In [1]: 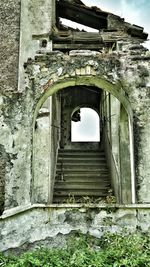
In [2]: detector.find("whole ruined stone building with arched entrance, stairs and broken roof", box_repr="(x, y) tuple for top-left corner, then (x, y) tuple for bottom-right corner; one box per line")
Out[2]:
(0, 0), (150, 251)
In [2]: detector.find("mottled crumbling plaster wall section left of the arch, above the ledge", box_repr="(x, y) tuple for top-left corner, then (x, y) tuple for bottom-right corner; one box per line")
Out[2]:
(0, 93), (32, 213)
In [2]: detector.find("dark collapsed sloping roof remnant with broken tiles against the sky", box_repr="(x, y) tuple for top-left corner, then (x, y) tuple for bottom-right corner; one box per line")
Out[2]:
(56, 0), (148, 40)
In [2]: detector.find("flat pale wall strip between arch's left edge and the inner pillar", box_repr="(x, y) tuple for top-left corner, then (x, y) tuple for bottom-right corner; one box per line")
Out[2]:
(32, 101), (50, 203)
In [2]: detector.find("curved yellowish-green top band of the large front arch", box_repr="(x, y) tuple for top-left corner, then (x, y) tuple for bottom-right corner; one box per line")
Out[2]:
(33, 75), (133, 121)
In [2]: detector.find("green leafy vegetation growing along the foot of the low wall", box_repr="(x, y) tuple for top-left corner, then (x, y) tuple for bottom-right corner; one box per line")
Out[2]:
(0, 233), (150, 267)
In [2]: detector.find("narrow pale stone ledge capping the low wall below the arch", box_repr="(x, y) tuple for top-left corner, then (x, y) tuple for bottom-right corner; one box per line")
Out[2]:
(0, 203), (150, 221)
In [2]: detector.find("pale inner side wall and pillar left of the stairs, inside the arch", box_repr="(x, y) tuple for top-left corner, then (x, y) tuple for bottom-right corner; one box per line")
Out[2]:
(32, 94), (61, 203)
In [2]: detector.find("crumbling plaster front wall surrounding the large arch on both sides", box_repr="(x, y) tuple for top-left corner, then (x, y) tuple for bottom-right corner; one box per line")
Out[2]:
(0, 44), (150, 216)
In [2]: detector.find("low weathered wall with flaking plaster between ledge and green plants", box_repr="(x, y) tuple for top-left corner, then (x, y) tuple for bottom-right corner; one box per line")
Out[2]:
(0, 204), (150, 253)
